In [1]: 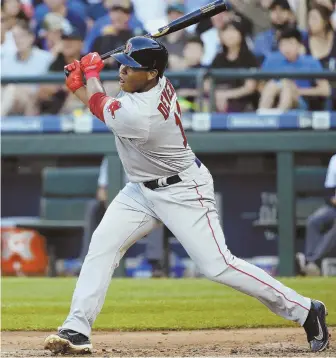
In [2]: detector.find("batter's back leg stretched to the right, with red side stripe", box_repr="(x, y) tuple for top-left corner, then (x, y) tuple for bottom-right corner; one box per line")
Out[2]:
(148, 162), (327, 348)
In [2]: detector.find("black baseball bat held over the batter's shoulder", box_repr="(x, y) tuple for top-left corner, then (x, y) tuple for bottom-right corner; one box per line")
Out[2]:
(64, 0), (231, 76)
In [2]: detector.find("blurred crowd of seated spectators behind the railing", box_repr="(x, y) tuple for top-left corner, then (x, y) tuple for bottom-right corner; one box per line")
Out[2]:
(1, 0), (336, 115)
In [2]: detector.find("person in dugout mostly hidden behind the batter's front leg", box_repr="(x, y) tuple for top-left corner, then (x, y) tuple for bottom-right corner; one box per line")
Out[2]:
(80, 158), (163, 277)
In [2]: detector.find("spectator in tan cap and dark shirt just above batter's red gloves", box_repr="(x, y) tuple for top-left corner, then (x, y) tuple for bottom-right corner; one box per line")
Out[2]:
(91, 1), (134, 69)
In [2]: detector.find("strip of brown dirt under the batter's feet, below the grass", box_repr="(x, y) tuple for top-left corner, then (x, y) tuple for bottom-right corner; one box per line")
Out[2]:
(1, 328), (336, 358)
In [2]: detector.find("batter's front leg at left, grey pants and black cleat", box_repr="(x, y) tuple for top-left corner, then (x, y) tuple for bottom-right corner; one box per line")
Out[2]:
(45, 184), (160, 353)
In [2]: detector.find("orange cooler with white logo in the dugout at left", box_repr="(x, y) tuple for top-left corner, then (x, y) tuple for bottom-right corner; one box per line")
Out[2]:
(1, 227), (48, 276)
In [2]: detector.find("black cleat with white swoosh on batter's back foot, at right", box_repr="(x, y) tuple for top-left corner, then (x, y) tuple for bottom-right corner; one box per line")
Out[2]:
(303, 300), (329, 352)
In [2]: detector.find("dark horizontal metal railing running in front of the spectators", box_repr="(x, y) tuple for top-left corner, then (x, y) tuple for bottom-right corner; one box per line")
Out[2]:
(1, 68), (336, 112)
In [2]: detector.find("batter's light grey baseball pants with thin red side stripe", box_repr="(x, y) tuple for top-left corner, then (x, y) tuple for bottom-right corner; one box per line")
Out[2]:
(62, 163), (311, 336)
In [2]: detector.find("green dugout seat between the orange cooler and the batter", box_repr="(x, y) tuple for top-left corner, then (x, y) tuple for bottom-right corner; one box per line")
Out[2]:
(16, 167), (99, 276)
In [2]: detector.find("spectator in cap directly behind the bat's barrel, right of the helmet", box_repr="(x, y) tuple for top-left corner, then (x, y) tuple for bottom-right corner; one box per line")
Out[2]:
(161, 3), (188, 70)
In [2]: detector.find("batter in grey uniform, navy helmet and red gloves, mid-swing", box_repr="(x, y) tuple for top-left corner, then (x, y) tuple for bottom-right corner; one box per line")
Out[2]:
(45, 36), (329, 354)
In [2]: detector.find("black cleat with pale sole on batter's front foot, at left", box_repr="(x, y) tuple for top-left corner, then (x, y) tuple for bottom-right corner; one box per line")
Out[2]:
(44, 329), (92, 354)
